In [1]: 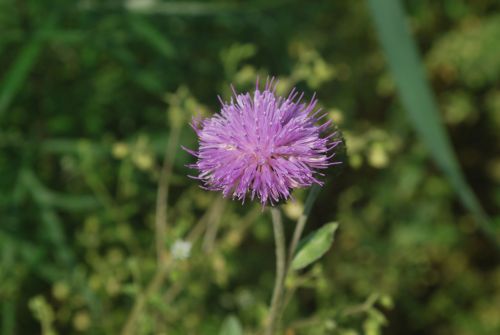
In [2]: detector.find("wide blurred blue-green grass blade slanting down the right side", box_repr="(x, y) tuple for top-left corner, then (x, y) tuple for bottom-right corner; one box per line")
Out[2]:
(368, 0), (498, 245)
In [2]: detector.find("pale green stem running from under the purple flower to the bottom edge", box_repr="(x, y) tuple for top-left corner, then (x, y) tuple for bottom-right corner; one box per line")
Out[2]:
(265, 207), (287, 335)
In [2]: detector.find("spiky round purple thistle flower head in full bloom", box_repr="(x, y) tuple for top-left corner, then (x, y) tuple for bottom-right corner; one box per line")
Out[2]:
(184, 80), (341, 205)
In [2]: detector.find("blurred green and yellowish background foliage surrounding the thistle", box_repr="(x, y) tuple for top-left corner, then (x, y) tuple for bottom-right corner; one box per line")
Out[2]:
(0, 0), (500, 335)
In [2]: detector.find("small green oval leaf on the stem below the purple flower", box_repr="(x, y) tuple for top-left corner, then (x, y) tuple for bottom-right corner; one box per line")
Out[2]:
(292, 222), (339, 270)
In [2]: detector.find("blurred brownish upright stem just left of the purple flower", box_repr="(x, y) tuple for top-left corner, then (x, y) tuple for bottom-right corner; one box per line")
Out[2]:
(155, 123), (181, 267)
